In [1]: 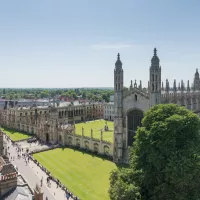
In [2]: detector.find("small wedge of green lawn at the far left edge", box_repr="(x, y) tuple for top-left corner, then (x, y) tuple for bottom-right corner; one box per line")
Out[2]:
(1, 128), (32, 141)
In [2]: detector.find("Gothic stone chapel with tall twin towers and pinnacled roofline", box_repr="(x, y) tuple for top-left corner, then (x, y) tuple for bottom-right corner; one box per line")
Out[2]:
(113, 48), (200, 163)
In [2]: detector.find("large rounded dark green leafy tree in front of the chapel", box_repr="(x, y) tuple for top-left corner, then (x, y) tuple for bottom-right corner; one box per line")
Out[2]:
(110, 104), (200, 200)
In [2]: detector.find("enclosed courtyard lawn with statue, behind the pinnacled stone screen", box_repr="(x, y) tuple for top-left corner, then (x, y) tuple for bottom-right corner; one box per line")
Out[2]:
(75, 120), (114, 142)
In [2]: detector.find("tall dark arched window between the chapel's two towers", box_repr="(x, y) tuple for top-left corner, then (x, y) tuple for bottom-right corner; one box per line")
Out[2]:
(127, 109), (144, 146)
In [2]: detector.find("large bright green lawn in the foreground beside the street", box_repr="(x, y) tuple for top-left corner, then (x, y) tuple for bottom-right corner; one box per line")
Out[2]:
(33, 148), (117, 200)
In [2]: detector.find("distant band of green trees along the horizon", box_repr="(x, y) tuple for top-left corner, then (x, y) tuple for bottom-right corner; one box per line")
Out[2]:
(0, 88), (114, 102)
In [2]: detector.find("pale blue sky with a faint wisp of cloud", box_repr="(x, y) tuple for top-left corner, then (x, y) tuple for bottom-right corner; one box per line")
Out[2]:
(0, 0), (200, 87)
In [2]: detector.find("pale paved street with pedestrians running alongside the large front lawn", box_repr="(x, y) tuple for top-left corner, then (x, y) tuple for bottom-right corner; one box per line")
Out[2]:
(7, 138), (74, 200)
